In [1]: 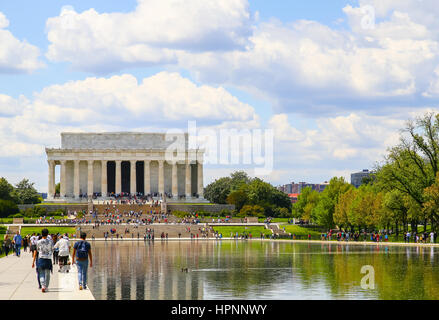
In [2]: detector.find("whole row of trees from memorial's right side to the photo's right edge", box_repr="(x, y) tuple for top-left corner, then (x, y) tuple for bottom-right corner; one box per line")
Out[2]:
(205, 113), (439, 234)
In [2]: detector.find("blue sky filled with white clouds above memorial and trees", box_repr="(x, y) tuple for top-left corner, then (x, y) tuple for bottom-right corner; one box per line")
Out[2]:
(0, 0), (439, 192)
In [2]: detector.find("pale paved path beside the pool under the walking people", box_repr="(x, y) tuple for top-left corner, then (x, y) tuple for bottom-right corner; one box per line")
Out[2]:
(0, 252), (94, 300)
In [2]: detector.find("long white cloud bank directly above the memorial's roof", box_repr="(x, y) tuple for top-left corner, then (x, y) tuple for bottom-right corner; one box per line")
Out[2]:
(0, 72), (258, 157)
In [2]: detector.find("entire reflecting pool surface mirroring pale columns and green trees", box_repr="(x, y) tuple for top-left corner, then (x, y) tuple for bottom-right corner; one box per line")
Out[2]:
(89, 241), (439, 300)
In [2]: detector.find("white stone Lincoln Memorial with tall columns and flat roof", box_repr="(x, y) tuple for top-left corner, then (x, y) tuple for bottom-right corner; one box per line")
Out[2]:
(46, 132), (204, 201)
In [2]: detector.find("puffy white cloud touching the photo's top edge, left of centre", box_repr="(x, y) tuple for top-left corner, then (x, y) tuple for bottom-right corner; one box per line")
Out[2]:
(46, 0), (250, 73)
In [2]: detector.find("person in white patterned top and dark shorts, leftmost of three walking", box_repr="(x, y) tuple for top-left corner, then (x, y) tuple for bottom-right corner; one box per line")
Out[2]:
(32, 229), (53, 292)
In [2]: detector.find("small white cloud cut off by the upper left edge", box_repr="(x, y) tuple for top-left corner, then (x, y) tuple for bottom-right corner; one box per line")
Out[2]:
(0, 12), (44, 74)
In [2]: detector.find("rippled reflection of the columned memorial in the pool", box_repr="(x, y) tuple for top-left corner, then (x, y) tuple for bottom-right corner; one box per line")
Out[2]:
(89, 240), (203, 300)
